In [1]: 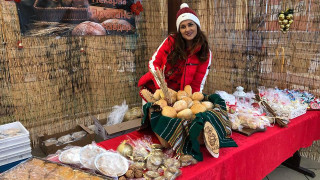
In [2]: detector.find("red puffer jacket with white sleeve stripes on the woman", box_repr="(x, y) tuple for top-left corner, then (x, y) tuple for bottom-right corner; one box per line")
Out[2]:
(138, 36), (212, 92)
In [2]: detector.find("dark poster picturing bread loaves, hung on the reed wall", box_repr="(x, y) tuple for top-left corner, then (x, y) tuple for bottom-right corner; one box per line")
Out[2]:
(16, 0), (139, 36)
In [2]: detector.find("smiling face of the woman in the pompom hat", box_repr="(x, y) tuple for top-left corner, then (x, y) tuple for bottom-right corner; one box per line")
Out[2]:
(179, 20), (197, 41)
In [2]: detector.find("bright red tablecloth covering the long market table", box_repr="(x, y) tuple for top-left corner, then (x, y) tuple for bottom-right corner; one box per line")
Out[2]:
(99, 111), (320, 180)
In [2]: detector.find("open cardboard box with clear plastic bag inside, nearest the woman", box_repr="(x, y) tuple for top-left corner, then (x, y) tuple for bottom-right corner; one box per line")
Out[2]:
(91, 116), (141, 142)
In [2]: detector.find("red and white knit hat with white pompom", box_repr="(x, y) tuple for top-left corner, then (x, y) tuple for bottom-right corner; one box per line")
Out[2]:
(176, 3), (200, 32)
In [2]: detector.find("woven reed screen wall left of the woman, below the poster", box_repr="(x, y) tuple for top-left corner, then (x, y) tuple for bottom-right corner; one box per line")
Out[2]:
(0, 0), (168, 145)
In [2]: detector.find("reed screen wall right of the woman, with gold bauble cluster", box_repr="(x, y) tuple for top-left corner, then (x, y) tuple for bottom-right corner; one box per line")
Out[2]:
(183, 0), (320, 161)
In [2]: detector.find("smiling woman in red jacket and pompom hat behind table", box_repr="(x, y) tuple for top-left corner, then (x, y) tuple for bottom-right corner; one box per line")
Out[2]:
(138, 3), (212, 98)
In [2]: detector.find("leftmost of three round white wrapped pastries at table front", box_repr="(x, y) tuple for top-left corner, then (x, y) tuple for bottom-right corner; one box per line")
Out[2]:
(59, 147), (81, 164)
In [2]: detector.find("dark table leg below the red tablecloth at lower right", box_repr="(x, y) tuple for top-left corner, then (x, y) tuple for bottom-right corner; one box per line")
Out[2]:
(282, 151), (316, 178)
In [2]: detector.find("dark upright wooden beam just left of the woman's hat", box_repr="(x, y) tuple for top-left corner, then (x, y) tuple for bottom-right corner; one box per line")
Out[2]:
(168, 0), (182, 34)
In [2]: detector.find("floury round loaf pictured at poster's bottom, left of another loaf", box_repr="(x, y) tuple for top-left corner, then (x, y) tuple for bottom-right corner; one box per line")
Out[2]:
(72, 21), (106, 36)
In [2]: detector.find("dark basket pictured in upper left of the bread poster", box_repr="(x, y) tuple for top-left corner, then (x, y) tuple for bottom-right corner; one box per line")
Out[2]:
(33, 0), (89, 23)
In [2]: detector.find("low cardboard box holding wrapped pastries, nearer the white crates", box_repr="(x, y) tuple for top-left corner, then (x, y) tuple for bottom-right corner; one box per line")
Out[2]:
(39, 124), (95, 155)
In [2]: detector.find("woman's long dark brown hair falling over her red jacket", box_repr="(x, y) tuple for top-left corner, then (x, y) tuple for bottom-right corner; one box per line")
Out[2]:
(167, 26), (209, 64)
